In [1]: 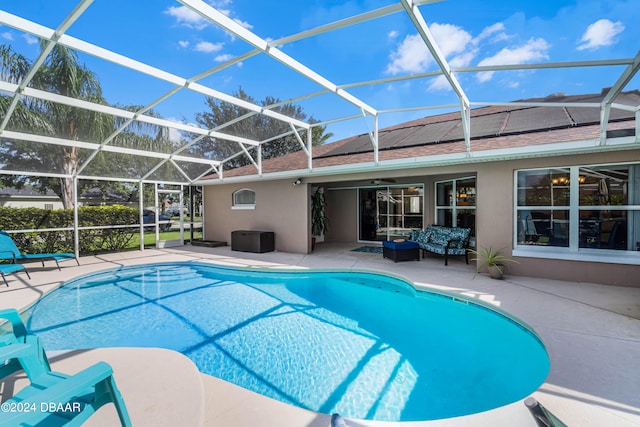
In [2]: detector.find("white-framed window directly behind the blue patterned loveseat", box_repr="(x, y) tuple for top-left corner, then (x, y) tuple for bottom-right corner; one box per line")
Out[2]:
(436, 177), (476, 241)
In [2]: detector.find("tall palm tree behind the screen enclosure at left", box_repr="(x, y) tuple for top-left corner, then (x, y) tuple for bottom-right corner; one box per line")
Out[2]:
(0, 44), (171, 208)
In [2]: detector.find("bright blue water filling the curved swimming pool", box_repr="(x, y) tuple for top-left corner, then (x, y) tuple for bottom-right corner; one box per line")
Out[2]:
(28, 263), (549, 421)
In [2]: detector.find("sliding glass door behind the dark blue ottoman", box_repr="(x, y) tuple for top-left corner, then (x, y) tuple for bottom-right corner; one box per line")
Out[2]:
(358, 185), (424, 241)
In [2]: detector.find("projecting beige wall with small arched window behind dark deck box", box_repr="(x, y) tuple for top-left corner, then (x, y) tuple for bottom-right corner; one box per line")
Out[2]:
(204, 180), (310, 253)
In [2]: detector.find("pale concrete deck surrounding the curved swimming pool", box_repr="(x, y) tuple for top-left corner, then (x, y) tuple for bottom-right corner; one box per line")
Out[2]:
(0, 244), (640, 427)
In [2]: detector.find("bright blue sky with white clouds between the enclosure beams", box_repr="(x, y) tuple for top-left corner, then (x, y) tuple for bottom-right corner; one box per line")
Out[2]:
(0, 0), (640, 139)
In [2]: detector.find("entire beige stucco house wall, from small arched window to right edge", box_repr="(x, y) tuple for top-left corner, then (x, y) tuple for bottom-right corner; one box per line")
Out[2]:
(204, 149), (640, 286)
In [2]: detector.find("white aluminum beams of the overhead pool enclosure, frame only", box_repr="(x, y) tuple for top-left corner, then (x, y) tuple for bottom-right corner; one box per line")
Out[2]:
(0, 0), (640, 189)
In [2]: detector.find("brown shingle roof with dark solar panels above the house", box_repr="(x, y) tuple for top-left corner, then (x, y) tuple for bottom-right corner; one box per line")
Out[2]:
(210, 90), (640, 178)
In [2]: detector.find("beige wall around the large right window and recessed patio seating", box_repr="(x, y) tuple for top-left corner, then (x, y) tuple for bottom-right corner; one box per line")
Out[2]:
(320, 150), (640, 286)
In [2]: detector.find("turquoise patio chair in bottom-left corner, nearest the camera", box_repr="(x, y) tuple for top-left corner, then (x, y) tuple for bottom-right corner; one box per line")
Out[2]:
(0, 342), (131, 427)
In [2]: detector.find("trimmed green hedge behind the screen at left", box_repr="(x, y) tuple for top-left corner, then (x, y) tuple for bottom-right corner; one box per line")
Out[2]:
(0, 205), (140, 254)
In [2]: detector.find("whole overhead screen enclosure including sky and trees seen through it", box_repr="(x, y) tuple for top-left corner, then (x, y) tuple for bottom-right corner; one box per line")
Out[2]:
(0, 0), (640, 251)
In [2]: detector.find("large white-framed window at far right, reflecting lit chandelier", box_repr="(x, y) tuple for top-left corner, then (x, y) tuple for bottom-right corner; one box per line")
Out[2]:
(515, 164), (640, 253)
